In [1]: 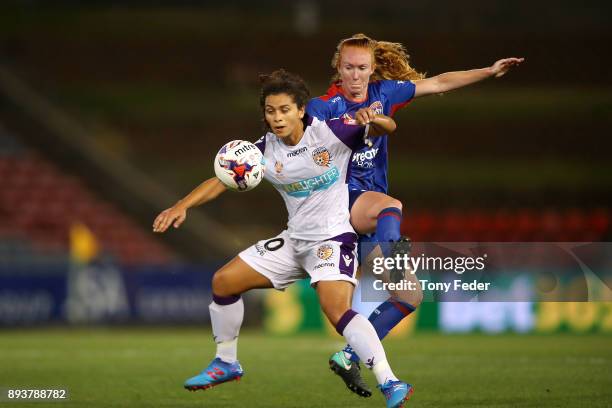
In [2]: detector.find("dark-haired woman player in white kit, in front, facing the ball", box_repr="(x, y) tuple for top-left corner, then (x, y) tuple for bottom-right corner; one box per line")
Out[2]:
(153, 70), (412, 407)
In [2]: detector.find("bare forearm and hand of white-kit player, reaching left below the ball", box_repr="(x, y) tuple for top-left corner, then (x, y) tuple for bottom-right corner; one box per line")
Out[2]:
(153, 177), (227, 232)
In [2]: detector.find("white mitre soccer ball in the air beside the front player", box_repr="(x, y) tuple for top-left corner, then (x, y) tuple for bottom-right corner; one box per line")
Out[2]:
(215, 140), (265, 191)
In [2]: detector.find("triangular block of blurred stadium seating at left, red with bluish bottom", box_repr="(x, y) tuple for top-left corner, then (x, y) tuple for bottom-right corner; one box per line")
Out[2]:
(0, 128), (175, 266)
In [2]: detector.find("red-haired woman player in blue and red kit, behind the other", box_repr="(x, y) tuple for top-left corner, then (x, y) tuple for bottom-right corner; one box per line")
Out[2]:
(306, 34), (523, 397)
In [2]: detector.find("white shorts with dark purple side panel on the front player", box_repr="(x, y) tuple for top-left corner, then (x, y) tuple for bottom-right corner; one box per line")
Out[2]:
(238, 230), (357, 290)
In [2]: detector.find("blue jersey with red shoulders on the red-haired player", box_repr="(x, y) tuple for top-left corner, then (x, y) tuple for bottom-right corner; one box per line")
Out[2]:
(306, 80), (415, 194)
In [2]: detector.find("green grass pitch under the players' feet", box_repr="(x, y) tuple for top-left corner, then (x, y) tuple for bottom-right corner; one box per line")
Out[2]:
(0, 328), (612, 408)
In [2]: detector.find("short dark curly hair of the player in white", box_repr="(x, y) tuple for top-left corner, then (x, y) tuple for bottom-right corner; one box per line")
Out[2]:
(259, 68), (310, 130)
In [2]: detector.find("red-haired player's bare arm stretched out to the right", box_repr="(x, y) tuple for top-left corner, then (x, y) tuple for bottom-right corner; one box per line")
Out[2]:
(414, 58), (525, 98)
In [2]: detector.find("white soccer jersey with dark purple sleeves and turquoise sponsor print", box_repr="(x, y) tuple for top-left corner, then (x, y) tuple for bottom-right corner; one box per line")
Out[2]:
(255, 117), (365, 241)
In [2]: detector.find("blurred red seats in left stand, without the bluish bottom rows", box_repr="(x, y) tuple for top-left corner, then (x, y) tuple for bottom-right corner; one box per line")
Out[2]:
(0, 151), (177, 263)
